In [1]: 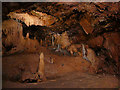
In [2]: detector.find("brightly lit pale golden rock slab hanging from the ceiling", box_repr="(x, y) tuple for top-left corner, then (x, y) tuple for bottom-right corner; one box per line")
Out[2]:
(7, 10), (55, 26)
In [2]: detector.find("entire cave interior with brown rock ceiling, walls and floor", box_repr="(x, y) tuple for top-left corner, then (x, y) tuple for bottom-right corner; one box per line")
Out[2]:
(1, 2), (120, 88)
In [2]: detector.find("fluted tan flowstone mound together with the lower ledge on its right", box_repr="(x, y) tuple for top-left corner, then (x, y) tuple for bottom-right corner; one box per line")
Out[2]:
(2, 19), (39, 55)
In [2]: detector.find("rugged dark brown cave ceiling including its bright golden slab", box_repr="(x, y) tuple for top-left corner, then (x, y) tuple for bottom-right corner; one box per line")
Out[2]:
(3, 2), (120, 35)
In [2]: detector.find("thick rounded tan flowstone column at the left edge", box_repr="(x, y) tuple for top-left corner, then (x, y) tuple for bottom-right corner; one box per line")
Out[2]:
(2, 19), (24, 54)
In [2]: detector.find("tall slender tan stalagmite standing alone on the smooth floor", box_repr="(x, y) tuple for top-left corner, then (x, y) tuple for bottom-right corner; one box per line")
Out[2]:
(38, 53), (46, 81)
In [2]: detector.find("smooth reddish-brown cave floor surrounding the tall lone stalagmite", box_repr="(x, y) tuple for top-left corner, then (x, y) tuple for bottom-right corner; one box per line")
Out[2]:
(2, 47), (119, 88)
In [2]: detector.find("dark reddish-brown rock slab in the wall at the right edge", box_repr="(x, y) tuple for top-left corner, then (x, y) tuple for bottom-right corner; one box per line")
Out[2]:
(104, 33), (120, 63)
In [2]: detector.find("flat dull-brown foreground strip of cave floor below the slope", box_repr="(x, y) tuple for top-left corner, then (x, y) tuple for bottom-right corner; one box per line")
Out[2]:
(3, 72), (118, 88)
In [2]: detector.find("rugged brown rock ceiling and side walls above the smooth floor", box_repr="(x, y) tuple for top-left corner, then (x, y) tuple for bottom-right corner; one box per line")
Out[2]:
(2, 2), (120, 74)
